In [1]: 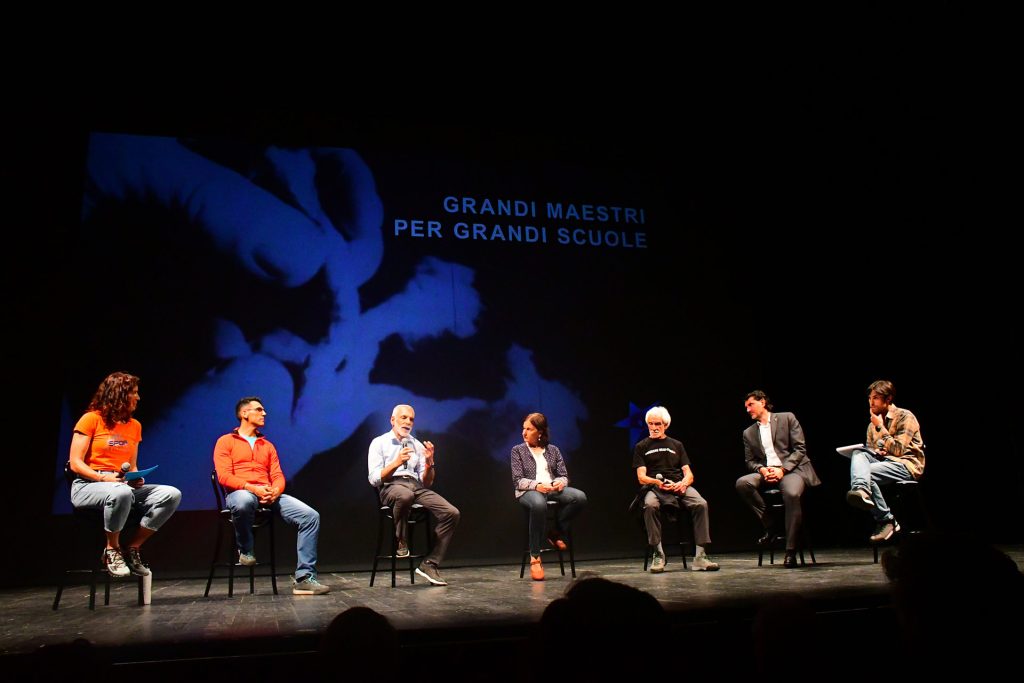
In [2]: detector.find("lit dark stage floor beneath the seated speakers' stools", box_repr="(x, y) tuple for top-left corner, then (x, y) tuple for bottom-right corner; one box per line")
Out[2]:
(0, 547), (1024, 675)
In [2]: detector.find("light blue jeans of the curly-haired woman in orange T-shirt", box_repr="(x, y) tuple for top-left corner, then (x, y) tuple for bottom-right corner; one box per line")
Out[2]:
(71, 479), (181, 532)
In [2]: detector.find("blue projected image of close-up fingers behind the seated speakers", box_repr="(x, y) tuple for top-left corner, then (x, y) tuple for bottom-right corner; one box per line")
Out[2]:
(54, 134), (588, 512)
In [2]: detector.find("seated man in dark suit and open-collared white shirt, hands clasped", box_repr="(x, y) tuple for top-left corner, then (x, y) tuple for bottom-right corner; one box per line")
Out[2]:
(736, 389), (821, 568)
